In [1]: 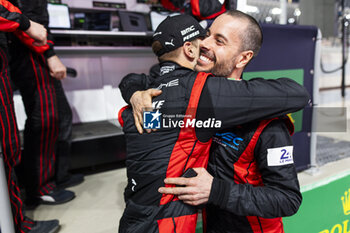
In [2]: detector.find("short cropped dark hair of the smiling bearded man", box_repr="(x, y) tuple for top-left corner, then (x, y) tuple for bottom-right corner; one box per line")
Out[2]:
(224, 10), (263, 57)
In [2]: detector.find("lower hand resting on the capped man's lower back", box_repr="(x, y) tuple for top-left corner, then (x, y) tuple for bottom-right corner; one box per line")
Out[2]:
(158, 168), (213, 206)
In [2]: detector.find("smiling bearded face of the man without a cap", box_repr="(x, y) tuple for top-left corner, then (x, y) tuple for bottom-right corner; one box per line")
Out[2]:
(196, 14), (248, 77)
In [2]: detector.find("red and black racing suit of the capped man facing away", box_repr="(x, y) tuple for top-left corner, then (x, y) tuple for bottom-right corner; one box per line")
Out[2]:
(118, 62), (309, 233)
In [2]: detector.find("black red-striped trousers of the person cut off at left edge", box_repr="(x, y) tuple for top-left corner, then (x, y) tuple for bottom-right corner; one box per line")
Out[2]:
(0, 45), (34, 233)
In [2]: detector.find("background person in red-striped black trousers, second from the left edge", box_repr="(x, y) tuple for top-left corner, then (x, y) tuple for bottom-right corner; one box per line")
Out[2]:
(9, 0), (83, 207)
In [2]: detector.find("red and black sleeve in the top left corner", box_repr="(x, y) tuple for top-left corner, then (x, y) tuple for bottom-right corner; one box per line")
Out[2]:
(0, 0), (30, 32)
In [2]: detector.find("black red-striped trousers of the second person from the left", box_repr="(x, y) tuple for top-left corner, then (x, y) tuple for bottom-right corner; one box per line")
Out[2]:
(9, 36), (72, 197)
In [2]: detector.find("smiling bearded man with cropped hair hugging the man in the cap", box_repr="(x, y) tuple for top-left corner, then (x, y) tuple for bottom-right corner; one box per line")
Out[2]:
(152, 11), (302, 233)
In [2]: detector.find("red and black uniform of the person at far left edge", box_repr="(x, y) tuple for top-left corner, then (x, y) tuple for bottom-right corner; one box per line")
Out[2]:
(0, 0), (34, 233)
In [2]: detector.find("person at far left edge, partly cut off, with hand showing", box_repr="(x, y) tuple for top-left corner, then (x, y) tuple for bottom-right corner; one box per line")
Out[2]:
(0, 0), (59, 233)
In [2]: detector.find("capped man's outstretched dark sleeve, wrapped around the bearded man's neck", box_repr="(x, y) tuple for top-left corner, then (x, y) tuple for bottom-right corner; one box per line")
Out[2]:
(197, 77), (310, 141)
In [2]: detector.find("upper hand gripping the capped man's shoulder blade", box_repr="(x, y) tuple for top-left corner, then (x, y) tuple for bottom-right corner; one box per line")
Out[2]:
(130, 89), (162, 134)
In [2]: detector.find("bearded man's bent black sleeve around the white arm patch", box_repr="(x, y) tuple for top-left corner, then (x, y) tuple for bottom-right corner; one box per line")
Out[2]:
(208, 121), (302, 218)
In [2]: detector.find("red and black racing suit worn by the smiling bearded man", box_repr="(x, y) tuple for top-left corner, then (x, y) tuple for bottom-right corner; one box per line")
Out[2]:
(206, 117), (302, 233)
